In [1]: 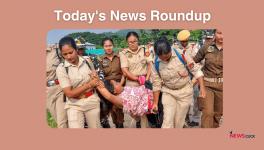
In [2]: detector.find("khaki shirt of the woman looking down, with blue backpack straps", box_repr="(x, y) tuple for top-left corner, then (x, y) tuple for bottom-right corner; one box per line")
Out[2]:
(151, 50), (203, 92)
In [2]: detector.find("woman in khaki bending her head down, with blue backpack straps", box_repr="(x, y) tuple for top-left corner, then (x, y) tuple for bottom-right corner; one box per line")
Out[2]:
(151, 38), (205, 128)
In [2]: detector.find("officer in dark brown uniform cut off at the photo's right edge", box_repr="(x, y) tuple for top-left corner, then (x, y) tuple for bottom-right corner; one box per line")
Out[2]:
(194, 29), (223, 128)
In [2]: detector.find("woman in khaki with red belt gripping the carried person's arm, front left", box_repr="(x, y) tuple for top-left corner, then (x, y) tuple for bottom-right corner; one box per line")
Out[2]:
(56, 37), (100, 128)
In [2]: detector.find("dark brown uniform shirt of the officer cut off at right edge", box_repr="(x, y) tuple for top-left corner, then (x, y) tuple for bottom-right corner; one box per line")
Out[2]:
(194, 43), (223, 78)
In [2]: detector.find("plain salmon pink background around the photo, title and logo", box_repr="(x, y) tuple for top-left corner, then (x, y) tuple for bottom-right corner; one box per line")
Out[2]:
(0, 0), (264, 150)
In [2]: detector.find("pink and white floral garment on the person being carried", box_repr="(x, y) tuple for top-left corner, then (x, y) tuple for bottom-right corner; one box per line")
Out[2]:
(120, 85), (153, 116)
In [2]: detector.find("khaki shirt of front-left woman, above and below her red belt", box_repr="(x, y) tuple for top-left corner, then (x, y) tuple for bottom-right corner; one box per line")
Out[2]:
(56, 56), (100, 111)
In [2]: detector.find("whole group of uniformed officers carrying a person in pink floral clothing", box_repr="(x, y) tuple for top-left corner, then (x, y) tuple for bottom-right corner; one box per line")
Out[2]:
(46, 29), (223, 128)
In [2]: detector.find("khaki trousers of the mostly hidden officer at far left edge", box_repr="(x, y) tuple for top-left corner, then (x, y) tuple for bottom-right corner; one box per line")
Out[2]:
(46, 85), (68, 128)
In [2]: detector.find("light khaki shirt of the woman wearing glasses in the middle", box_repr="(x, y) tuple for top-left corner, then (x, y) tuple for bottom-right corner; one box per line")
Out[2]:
(119, 47), (153, 86)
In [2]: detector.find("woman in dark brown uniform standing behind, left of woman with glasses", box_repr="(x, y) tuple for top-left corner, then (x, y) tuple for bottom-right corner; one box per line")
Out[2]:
(100, 38), (125, 128)
